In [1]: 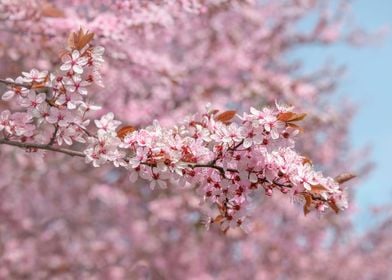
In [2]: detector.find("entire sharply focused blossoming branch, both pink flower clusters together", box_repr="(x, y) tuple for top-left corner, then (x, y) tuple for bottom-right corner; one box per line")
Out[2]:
(0, 30), (346, 231)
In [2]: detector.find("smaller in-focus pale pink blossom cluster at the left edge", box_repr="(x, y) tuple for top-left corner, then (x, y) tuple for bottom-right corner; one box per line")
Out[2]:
(0, 30), (104, 145)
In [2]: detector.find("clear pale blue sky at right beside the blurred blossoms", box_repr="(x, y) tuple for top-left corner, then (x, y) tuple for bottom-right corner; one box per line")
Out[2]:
(297, 0), (392, 230)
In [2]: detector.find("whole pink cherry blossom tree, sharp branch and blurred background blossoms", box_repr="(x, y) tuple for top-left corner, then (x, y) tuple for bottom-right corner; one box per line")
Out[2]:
(0, 0), (392, 279)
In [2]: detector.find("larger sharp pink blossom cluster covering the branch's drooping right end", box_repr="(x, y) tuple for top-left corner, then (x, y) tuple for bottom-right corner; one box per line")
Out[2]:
(90, 105), (346, 230)
